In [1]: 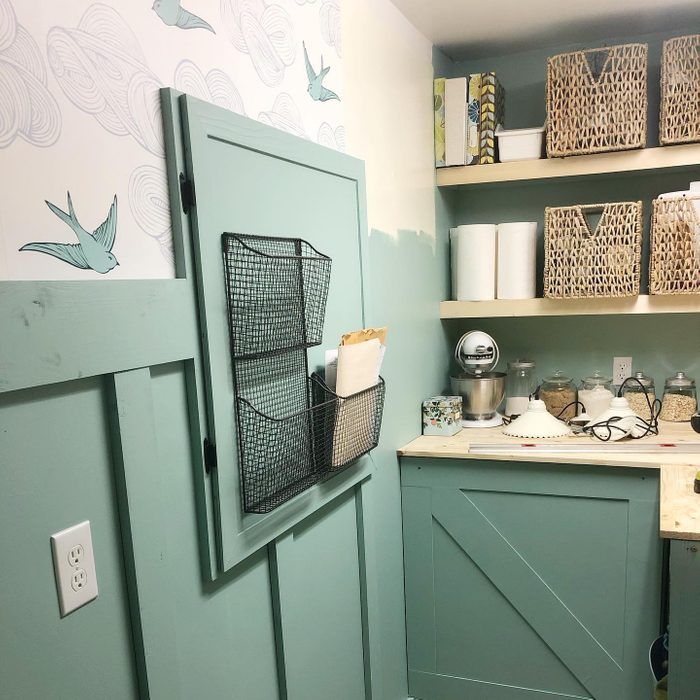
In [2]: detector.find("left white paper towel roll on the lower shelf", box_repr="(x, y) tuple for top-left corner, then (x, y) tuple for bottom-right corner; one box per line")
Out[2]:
(452, 224), (496, 301)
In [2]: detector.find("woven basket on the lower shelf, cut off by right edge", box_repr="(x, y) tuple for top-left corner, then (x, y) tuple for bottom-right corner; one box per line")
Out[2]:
(649, 197), (700, 294)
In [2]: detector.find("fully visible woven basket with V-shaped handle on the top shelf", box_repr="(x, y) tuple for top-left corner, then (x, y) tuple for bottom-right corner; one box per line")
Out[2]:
(547, 44), (648, 158)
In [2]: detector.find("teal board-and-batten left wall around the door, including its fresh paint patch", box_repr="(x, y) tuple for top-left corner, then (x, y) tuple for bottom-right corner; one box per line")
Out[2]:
(0, 86), (447, 700)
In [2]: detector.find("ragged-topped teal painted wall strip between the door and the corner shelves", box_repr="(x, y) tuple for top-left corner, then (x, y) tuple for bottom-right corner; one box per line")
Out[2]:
(366, 229), (447, 700)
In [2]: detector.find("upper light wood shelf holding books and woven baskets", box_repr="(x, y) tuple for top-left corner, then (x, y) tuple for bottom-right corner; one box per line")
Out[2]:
(437, 144), (700, 187)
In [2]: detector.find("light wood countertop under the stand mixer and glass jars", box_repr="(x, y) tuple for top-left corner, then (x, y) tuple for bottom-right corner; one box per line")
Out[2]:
(397, 422), (700, 540)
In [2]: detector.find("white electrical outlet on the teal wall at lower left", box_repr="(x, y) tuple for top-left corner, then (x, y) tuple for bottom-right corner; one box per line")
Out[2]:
(51, 520), (97, 617)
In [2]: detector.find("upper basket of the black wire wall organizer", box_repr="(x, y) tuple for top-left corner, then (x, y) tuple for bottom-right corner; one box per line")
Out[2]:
(222, 233), (331, 359)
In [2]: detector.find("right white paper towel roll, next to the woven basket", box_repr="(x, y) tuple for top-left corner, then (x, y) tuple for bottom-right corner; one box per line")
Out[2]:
(497, 221), (537, 299)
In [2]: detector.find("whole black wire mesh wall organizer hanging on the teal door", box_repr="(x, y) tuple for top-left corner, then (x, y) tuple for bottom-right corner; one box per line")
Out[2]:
(222, 233), (385, 513)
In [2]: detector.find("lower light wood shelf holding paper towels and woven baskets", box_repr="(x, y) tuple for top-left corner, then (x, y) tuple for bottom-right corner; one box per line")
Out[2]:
(440, 292), (700, 319)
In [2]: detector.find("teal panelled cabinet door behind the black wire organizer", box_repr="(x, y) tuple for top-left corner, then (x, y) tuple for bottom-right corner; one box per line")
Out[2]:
(172, 91), (372, 570)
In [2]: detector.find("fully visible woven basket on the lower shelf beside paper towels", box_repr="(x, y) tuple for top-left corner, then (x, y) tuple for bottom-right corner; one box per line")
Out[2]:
(544, 202), (642, 299)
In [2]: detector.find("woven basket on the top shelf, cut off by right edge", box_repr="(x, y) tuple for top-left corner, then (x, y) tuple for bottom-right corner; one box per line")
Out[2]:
(659, 34), (700, 145)
